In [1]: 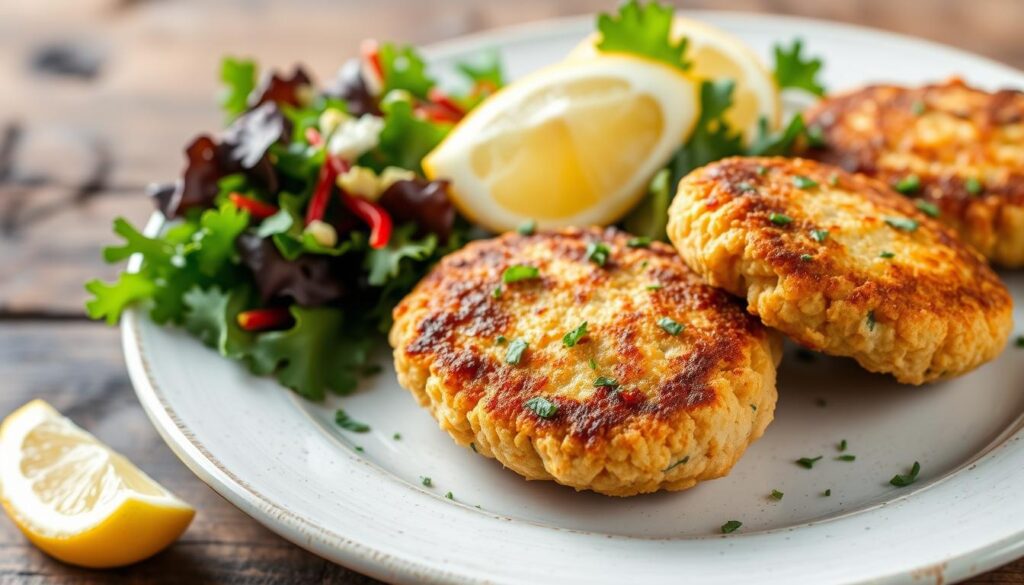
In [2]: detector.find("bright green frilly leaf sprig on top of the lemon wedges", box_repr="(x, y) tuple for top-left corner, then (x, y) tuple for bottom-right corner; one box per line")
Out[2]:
(597, 0), (690, 71)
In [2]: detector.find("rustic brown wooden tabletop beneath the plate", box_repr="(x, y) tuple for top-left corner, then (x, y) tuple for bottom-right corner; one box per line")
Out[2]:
(0, 0), (1024, 584)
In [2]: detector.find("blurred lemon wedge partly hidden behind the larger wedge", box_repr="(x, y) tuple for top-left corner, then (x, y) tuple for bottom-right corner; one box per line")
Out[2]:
(568, 16), (781, 141)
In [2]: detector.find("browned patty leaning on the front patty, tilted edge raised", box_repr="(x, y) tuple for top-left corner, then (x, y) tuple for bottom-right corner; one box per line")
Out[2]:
(669, 158), (1012, 384)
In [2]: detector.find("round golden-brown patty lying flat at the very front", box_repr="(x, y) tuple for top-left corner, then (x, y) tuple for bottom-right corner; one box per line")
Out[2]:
(390, 228), (780, 496)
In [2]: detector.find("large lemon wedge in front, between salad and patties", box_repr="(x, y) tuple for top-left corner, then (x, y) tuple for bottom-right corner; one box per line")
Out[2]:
(423, 54), (698, 232)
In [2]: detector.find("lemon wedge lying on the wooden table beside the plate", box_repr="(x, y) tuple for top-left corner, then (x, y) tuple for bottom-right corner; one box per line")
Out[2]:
(0, 401), (195, 568)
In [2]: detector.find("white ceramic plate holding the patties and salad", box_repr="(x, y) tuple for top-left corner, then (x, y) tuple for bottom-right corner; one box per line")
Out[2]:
(124, 12), (1024, 584)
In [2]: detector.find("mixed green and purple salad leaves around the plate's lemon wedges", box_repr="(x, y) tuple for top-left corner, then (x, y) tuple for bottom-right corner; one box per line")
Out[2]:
(86, 0), (823, 400)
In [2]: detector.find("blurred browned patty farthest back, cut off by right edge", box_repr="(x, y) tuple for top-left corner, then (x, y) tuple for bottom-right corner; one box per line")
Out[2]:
(805, 80), (1024, 266)
